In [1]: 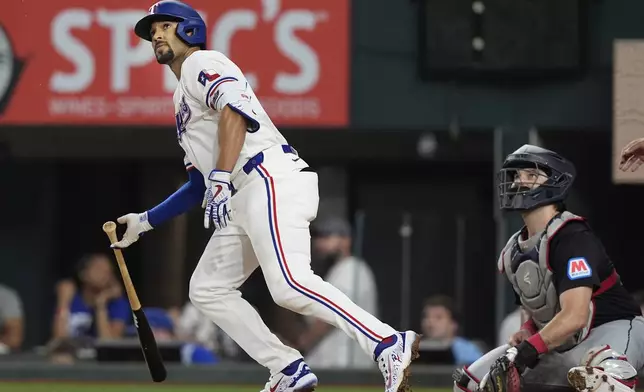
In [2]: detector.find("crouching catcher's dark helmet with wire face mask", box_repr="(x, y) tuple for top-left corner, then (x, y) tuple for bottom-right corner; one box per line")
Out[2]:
(497, 144), (577, 211)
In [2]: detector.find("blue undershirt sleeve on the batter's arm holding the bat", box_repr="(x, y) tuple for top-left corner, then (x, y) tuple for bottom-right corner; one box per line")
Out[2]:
(148, 168), (206, 227)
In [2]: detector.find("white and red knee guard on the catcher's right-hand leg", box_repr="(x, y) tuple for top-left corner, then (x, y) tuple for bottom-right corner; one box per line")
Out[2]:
(568, 344), (638, 392)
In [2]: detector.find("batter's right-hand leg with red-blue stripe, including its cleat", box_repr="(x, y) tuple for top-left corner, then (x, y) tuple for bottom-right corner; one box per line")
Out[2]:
(240, 165), (419, 390)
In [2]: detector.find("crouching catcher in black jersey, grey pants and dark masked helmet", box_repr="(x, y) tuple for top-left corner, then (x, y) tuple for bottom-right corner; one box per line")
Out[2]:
(454, 145), (644, 392)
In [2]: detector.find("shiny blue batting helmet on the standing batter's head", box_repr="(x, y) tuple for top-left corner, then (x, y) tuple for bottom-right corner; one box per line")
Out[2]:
(134, 0), (206, 49)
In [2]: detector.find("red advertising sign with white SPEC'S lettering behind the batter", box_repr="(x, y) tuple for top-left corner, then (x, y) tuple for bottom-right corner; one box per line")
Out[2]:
(0, 0), (350, 127)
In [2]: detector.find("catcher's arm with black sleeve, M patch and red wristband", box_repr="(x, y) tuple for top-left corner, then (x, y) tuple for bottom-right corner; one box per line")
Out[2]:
(528, 231), (603, 353)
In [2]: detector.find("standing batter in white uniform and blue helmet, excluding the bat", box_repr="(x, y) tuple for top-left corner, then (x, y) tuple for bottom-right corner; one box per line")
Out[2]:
(115, 0), (420, 392)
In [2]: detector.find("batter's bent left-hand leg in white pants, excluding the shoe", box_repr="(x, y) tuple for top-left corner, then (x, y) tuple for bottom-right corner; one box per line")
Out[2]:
(189, 225), (302, 374)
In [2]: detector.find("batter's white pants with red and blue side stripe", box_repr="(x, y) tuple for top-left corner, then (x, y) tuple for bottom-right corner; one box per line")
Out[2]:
(189, 145), (396, 374)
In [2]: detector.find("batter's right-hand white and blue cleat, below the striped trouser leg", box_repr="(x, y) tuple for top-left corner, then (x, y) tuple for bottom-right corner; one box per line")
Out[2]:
(374, 331), (421, 392)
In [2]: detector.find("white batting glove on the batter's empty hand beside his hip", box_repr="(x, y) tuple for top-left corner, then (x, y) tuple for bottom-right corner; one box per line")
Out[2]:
(201, 169), (233, 230)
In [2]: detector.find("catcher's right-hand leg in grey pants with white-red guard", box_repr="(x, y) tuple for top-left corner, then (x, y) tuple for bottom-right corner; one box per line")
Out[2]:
(564, 317), (644, 392)
